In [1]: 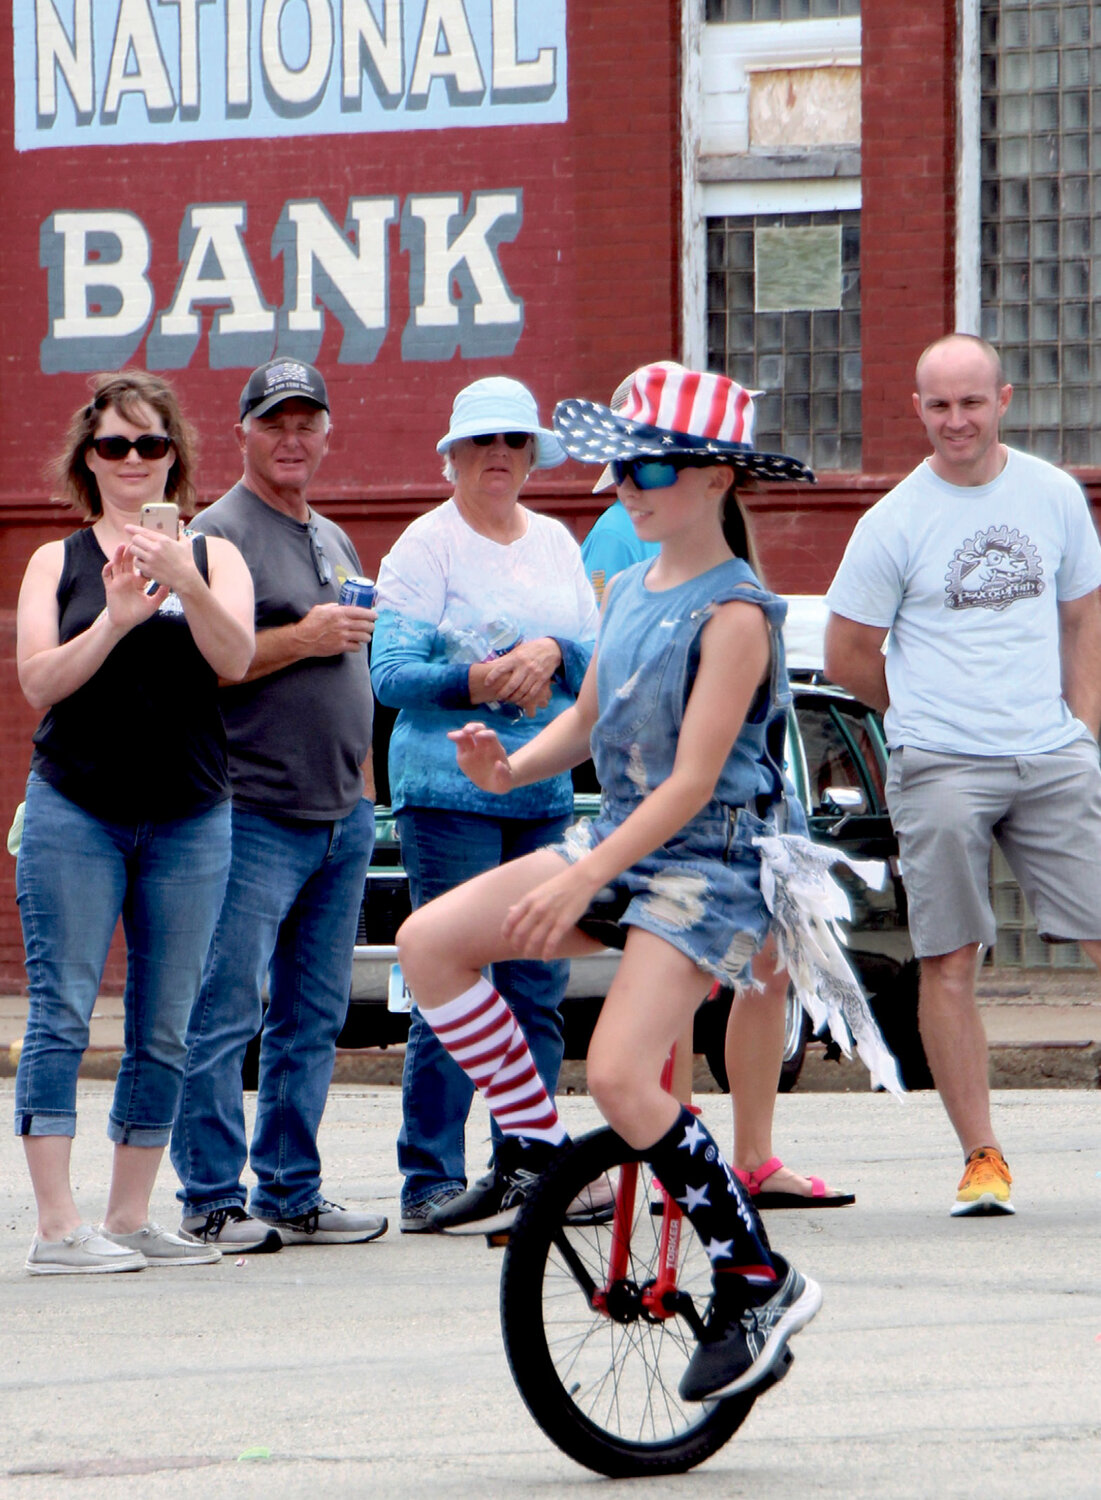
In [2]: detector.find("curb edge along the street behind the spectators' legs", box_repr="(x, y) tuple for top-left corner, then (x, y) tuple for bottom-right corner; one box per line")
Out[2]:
(0, 1041), (1101, 1094)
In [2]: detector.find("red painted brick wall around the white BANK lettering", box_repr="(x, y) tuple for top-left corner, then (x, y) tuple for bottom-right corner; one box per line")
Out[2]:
(0, 0), (690, 987)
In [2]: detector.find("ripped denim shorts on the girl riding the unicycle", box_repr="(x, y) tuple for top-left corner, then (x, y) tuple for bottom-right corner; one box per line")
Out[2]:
(549, 807), (776, 984)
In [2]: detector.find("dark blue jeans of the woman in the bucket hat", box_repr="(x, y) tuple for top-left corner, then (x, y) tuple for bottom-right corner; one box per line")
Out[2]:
(398, 807), (570, 1211)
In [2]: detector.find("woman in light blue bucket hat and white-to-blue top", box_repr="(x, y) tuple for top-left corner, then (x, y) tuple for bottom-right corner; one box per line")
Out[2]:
(371, 375), (597, 1235)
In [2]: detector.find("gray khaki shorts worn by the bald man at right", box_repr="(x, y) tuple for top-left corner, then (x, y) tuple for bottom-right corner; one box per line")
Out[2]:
(887, 734), (1101, 959)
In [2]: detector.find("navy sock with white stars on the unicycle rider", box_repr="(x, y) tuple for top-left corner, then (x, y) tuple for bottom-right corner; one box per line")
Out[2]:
(644, 1109), (776, 1281)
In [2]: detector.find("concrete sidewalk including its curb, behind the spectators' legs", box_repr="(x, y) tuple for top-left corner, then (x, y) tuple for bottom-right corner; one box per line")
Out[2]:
(0, 969), (1101, 1094)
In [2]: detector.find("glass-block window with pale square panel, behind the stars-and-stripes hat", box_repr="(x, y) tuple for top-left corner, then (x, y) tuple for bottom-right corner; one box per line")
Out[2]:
(708, 209), (861, 471)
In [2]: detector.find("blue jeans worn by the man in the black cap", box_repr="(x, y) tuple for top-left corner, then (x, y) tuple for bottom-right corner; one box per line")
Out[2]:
(173, 801), (375, 1218)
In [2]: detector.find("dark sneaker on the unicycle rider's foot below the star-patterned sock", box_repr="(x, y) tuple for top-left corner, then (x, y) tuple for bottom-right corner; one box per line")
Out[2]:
(680, 1254), (822, 1401)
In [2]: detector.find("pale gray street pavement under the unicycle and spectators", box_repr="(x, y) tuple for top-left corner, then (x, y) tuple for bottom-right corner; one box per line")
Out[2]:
(0, 1079), (1101, 1500)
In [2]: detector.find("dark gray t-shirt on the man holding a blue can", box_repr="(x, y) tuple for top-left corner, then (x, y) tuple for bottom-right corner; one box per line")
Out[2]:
(194, 483), (374, 822)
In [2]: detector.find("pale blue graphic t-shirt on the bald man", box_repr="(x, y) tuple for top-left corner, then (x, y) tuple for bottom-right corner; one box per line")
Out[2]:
(827, 449), (1101, 756)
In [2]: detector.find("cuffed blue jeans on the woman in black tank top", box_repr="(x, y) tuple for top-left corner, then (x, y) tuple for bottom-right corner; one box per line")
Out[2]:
(15, 773), (230, 1146)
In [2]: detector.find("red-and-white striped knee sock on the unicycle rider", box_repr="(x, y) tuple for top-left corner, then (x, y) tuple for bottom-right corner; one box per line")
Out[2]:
(422, 980), (569, 1146)
